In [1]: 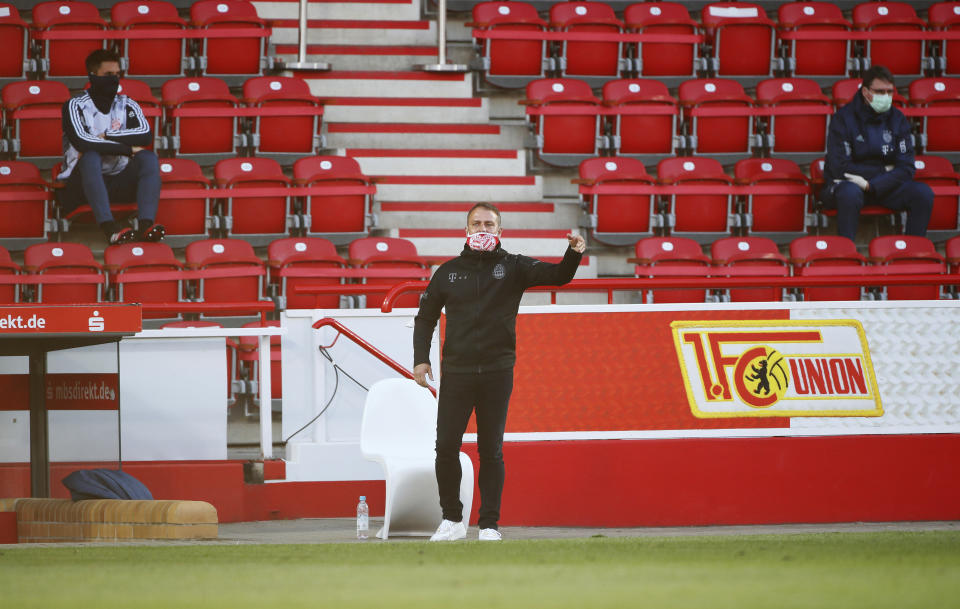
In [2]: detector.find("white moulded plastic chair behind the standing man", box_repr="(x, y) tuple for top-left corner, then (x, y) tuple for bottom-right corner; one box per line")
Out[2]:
(360, 378), (473, 540)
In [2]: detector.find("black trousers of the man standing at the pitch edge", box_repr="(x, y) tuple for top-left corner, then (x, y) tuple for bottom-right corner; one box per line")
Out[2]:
(436, 368), (513, 529)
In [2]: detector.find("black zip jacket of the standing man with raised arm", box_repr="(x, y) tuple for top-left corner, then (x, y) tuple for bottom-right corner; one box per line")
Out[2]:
(413, 245), (581, 373)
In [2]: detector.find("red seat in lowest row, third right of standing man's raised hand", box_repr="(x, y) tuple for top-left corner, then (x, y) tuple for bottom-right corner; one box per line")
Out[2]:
(790, 235), (873, 301)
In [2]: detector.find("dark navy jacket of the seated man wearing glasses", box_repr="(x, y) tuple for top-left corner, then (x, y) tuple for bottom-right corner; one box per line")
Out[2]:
(823, 91), (914, 197)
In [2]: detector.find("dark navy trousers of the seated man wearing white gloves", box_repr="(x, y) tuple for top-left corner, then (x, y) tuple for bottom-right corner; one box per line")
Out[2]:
(820, 180), (933, 241)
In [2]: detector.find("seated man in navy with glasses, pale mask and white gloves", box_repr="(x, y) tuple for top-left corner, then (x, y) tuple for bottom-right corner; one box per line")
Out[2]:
(820, 66), (933, 241)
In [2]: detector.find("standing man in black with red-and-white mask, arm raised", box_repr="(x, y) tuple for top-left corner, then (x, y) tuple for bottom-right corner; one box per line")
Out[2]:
(413, 203), (585, 541)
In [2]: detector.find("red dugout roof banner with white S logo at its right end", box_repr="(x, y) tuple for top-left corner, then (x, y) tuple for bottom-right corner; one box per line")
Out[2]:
(0, 304), (142, 337)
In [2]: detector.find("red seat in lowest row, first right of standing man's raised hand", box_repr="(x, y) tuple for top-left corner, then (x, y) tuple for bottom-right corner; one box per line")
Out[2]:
(630, 237), (712, 304)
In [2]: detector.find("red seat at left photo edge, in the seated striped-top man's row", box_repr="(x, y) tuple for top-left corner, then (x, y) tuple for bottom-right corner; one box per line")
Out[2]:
(0, 161), (52, 246)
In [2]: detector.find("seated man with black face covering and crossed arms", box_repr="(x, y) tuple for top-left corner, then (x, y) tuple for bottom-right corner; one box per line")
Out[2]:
(57, 49), (165, 245)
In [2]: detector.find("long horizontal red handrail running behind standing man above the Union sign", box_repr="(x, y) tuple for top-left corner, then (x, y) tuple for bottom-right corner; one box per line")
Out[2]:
(380, 276), (960, 313)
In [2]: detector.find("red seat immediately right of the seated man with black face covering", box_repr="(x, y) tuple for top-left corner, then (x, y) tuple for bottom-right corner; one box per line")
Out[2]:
(156, 159), (212, 242)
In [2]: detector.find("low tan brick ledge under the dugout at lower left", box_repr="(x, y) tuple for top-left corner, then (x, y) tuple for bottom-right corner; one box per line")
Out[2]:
(12, 499), (218, 543)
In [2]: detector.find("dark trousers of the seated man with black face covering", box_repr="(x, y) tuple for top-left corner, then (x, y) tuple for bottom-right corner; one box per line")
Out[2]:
(61, 150), (160, 224)
